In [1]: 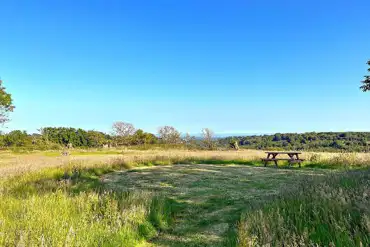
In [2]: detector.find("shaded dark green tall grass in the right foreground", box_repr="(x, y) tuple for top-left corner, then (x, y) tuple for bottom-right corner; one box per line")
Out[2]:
(238, 169), (370, 247)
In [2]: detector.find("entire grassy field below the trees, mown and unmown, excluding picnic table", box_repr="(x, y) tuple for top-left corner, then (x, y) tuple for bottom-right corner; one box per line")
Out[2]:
(0, 150), (370, 246)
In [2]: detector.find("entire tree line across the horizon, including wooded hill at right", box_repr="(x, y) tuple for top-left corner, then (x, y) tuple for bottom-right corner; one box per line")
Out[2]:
(0, 125), (370, 152)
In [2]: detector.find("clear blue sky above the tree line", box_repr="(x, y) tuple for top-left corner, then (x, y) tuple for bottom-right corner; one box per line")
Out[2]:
(0, 0), (370, 133)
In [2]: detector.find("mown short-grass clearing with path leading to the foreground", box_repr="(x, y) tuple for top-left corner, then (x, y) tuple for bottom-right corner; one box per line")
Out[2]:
(103, 165), (323, 246)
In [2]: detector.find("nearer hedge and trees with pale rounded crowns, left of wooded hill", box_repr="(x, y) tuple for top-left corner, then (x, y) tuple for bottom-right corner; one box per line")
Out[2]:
(0, 121), (217, 150)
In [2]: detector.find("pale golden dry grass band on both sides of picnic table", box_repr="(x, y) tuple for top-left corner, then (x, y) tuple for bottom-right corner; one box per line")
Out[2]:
(0, 149), (370, 178)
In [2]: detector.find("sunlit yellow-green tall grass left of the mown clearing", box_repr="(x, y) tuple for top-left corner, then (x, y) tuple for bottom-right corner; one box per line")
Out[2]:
(0, 157), (178, 246)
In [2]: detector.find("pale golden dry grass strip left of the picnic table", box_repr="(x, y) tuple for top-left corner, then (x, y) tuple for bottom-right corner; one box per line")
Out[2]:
(0, 150), (264, 178)
